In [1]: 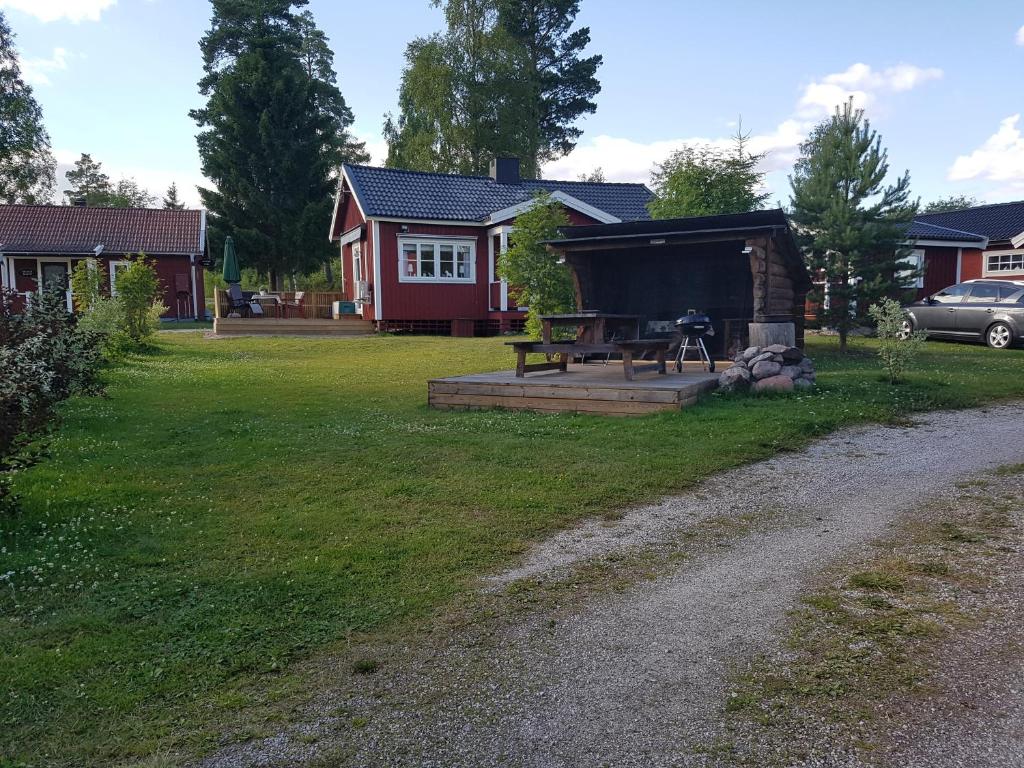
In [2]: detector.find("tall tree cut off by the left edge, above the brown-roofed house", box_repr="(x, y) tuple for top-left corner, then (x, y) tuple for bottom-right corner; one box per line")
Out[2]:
(0, 12), (56, 204)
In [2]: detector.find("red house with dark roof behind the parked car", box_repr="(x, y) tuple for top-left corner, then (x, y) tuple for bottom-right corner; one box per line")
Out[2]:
(908, 201), (1024, 297)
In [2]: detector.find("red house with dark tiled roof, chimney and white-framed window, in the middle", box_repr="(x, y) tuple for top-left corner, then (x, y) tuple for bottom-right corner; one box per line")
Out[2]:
(331, 158), (652, 335)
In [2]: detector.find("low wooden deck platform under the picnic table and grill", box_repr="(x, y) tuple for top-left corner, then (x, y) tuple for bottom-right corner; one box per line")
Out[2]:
(427, 361), (718, 416)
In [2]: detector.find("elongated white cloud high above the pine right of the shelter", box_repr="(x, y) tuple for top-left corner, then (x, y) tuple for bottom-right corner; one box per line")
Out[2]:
(798, 62), (942, 117)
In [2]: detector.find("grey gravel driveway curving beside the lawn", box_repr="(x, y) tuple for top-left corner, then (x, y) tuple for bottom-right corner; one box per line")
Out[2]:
(205, 406), (1024, 768)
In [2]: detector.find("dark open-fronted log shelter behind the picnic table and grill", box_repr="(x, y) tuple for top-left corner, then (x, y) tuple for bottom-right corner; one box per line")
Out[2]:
(547, 209), (811, 354)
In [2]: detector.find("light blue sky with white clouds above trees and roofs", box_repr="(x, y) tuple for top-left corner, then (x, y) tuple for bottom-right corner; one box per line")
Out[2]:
(8, 0), (1024, 210)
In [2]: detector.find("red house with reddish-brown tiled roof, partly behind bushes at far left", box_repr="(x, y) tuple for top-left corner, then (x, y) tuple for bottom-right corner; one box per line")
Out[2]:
(0, 205), (207, 319)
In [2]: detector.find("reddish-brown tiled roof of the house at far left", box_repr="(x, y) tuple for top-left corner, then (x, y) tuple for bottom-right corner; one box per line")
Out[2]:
(0, 205), (206, 255)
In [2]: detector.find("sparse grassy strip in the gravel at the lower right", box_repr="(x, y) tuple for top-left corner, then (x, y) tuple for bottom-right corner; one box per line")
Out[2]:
(725, 471), (1024, 765)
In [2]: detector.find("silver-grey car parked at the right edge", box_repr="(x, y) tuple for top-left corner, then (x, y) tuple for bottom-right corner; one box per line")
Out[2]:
(903, 280), (1024, 349)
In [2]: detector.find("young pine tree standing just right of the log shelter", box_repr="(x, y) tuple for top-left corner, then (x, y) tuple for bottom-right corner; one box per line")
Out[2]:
(790, 100), (918, 352)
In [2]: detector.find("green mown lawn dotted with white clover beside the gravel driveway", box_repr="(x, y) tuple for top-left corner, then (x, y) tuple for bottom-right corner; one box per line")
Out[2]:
(0, 333), (1024, 766)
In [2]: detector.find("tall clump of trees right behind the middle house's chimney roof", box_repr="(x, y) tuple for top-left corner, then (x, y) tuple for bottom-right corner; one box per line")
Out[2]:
(384, 0), (601, 178)
